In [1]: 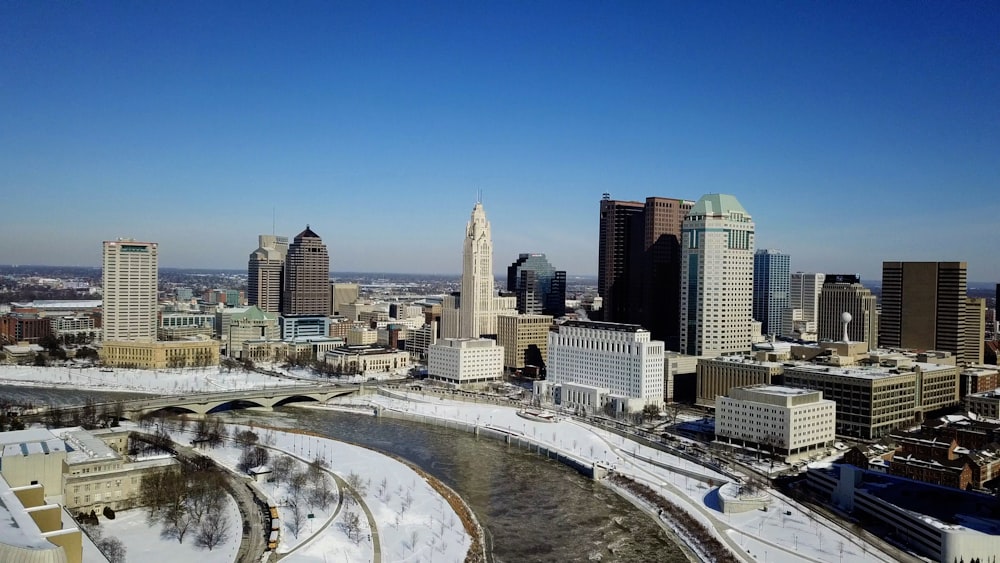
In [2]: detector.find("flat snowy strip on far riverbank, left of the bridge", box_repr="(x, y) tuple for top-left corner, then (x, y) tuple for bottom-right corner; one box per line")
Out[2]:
(0, 365), (312, 395)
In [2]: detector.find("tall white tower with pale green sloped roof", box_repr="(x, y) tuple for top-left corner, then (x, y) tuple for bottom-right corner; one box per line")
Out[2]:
(680, 194), (754, 356)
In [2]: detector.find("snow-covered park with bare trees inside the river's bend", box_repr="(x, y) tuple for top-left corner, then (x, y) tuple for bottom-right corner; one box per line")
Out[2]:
(129, 425), (472, 563)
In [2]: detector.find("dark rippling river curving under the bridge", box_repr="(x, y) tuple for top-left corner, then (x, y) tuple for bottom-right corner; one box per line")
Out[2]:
(0, 386), (687, 563)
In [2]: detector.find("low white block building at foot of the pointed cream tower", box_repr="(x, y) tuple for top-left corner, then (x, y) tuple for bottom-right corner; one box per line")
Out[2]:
(427, 338), (503, 385)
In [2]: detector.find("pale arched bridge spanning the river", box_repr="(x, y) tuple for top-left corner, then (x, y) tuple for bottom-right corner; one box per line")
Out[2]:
(123, 385), (364, 420)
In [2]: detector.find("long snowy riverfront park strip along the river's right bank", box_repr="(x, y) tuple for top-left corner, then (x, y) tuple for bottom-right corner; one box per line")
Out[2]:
(344, 392), (893, 562)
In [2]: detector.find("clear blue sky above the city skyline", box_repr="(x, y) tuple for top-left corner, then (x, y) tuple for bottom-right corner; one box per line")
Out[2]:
(0, 1), (1000, 281)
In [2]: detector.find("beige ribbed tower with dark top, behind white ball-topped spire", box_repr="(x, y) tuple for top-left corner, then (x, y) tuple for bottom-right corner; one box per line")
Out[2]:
(816, 274), (879, 350)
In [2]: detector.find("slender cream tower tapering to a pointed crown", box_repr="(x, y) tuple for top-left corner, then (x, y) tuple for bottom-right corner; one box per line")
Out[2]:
(458, 201), (497, 338)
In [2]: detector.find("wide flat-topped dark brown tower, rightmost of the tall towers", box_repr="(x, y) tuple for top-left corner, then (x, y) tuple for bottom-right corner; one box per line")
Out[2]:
(879, 262), (966, 362)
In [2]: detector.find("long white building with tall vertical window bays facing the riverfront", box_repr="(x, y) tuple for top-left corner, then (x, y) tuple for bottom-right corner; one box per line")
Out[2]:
(547, 321), (664, 410)
